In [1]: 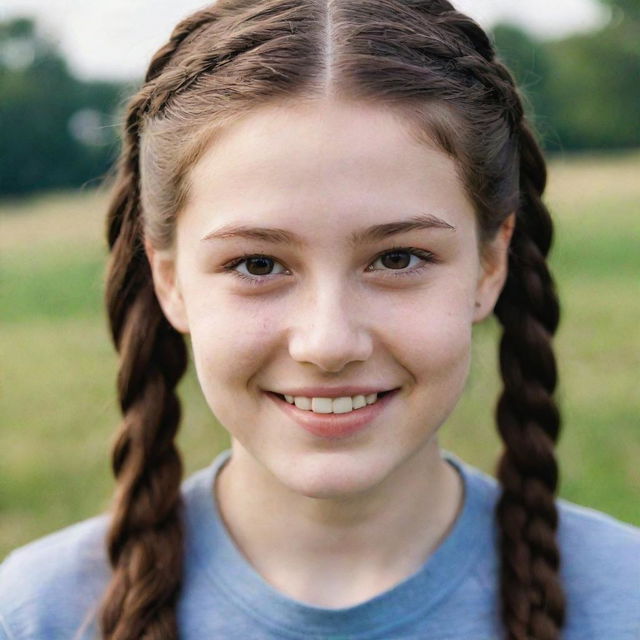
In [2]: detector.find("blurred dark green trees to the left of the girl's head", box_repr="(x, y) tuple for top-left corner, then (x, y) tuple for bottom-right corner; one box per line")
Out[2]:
(0, 18), (123, 196)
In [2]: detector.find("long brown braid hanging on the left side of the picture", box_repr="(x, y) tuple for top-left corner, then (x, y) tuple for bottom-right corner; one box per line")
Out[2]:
(100, 17), (204, 640)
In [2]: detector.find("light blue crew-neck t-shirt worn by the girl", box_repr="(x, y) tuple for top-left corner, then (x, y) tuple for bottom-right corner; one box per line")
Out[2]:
(0, 449), (640, 640)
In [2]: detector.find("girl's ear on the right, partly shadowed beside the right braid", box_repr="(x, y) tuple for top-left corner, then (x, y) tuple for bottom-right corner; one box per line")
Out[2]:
(473, 213), (516, 324)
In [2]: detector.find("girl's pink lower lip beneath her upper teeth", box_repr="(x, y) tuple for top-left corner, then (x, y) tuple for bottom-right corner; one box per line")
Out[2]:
(265, 389), (399, 440)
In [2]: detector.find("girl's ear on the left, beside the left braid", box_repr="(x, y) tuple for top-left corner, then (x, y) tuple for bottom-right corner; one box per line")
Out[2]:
(144, 240), (189, 333)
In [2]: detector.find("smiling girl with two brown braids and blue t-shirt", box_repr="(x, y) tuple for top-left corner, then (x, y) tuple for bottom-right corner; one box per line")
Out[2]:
(0, 0), (640, 640)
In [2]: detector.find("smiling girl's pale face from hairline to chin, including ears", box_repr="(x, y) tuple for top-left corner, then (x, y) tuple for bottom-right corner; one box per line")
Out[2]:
(147, 102), (510, 497)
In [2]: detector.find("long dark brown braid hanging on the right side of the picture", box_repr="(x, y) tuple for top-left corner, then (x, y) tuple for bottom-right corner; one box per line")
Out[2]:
(495, 117), (565, 640)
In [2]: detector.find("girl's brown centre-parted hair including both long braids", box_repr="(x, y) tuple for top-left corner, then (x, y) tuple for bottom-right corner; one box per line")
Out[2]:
(100, 0), (565, 640)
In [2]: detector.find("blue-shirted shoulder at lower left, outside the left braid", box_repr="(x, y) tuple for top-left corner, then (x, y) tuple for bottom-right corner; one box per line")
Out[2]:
(0, 514), (108, 640)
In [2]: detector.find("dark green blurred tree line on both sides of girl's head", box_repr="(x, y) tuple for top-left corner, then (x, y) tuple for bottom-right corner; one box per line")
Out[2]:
(0, 0), (640, 197)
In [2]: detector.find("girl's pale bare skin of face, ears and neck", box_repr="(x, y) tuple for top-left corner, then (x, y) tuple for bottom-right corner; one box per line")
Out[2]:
(146, 99), (515, 608)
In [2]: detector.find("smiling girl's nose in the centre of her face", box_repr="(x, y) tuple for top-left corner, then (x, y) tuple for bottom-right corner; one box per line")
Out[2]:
(289, 283), (373, 373)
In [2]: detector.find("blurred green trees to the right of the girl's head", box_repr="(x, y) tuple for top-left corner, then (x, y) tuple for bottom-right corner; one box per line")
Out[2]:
(493, 0), (640, 152)
